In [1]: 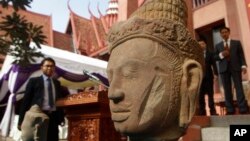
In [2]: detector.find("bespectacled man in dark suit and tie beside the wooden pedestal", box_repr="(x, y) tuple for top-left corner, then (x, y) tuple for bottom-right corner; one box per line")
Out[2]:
(18, 58), (64, 141)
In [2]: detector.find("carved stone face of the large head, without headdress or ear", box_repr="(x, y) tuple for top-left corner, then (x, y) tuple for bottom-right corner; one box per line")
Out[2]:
(107, 38), (180, 134)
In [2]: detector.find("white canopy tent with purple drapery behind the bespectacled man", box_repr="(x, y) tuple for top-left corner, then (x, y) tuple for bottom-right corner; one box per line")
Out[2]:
(0, 44), (107, 136)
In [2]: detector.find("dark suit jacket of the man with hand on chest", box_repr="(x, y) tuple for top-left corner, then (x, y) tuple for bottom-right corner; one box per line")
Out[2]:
(215, 40), (247, 73)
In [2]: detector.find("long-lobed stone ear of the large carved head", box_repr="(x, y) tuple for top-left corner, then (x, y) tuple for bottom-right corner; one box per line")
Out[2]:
(179, 60), (202, 127)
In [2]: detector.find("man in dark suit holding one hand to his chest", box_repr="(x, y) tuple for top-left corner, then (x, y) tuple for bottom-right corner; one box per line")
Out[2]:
(215, 27), (248, 115)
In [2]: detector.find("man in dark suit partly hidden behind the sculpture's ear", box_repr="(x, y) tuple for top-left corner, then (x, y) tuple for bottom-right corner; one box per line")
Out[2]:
(198, 39), (218, 116)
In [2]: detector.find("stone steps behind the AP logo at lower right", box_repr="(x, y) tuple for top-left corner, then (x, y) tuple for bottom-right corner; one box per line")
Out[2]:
(182, 115), (250, 141)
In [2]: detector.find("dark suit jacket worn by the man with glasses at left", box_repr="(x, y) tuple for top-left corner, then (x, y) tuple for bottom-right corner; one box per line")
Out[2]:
(18, 76), (64, 125)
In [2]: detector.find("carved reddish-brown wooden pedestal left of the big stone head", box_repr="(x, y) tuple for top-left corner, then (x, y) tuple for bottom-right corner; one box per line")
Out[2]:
(57, 91), (125, 141)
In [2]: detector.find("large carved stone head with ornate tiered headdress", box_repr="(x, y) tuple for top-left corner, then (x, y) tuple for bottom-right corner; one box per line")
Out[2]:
(107, 0), (203, 141)
